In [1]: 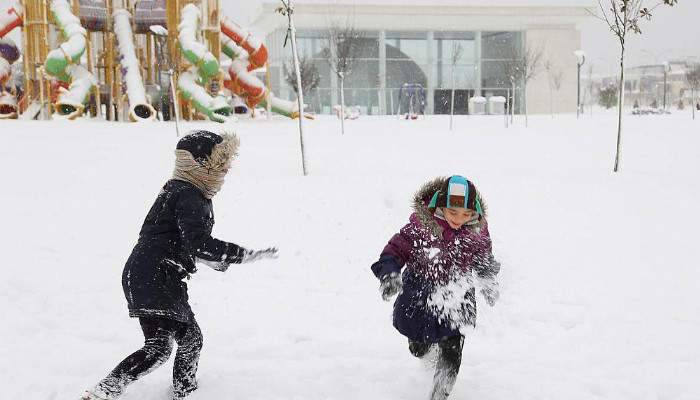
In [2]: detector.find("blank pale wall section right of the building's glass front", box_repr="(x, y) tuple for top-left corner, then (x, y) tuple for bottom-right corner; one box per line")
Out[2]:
(525, 26), (585, 114)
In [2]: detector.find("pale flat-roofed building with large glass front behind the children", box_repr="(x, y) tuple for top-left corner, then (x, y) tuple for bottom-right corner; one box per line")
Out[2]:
(253, 0), (590, 114)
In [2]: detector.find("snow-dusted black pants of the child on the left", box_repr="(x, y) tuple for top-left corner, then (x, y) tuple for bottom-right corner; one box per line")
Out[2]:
(98, 317), (202, 398)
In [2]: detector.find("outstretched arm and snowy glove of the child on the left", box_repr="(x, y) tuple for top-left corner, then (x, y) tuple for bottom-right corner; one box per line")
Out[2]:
(175, 191), (277, 271)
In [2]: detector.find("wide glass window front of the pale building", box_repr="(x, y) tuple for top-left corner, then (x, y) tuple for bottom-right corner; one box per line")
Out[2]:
(271, 30), (524, 113)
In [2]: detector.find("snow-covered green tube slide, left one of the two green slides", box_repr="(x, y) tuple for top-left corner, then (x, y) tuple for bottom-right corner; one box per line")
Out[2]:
(46, 0), (97, 119)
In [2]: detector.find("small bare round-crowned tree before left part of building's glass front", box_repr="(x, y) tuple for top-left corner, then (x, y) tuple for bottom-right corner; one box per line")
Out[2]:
(322, 19), (364, 134)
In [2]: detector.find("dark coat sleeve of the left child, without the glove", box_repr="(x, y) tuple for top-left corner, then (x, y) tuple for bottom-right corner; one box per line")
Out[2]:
(175, 191), (245, 270)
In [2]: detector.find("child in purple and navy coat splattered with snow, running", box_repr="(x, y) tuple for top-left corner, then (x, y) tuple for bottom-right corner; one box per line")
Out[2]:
(372, 176), (500, 400)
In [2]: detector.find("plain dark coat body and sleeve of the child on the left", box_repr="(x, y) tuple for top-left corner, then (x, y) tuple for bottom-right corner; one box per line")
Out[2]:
(122, 180), (243, 322)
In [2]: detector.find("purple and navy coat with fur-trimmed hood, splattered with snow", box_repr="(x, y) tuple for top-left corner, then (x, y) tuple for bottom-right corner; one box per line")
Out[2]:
(372, 178), (499, 343)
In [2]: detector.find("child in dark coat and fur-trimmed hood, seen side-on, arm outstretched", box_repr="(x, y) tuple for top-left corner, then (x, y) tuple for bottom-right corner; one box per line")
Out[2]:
(81, 131), (277, 400)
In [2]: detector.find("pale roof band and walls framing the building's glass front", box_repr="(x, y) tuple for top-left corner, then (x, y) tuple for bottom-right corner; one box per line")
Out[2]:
(253, 1), (588, 114)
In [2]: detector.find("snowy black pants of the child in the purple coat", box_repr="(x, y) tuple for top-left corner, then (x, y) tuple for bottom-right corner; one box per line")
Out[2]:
(408, 336), (464, 400)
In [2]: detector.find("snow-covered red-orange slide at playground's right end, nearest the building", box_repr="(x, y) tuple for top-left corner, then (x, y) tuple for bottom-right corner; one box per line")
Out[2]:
(221, 17), (313, 119)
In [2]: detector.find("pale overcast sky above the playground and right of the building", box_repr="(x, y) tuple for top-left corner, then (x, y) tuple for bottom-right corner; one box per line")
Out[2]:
(0, 0), (700, 74)
